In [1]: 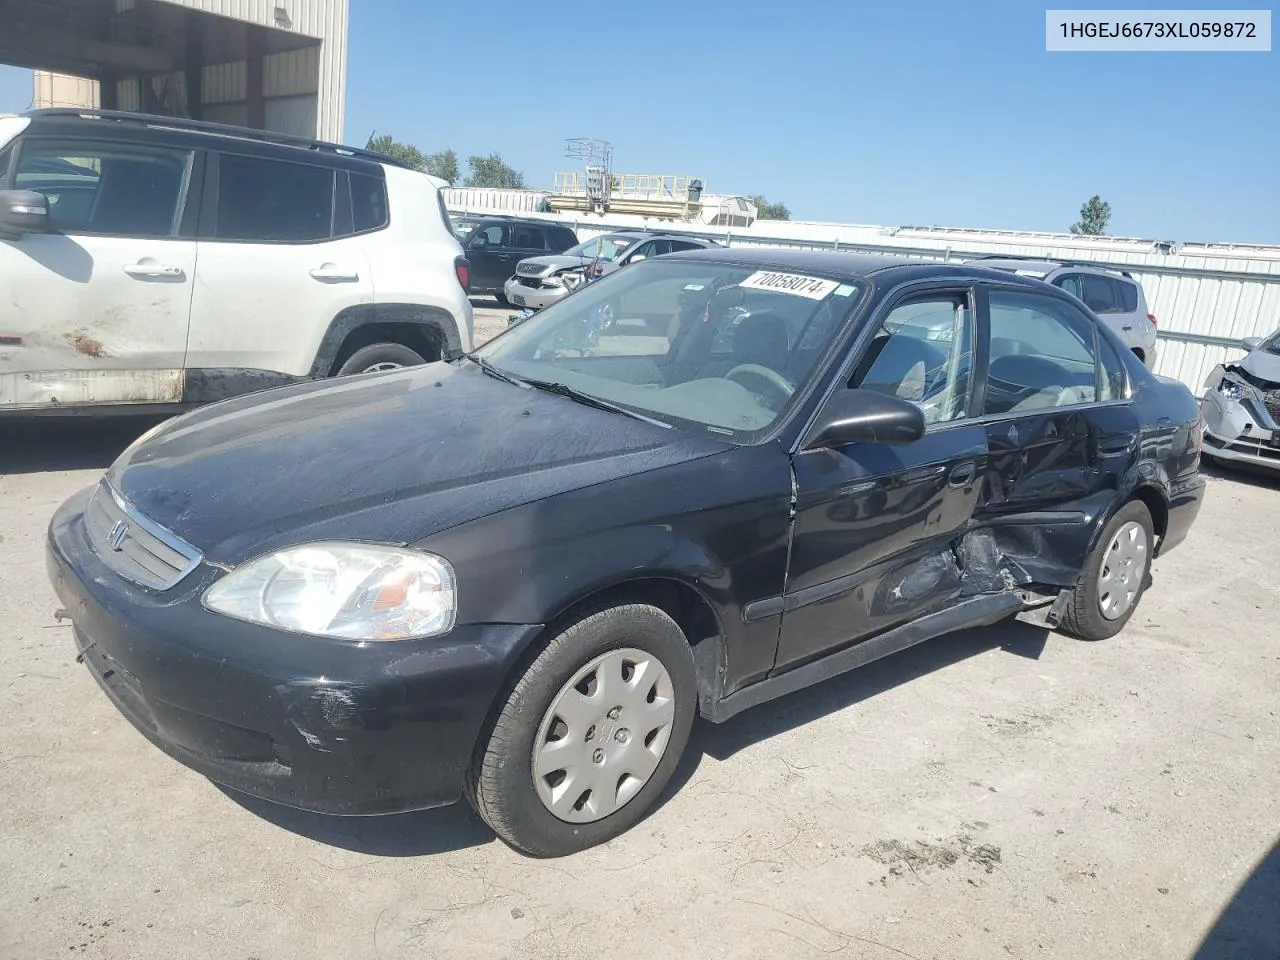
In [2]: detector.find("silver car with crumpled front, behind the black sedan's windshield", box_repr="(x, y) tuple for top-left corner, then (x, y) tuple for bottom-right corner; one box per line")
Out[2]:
(506, 230), (721, 310)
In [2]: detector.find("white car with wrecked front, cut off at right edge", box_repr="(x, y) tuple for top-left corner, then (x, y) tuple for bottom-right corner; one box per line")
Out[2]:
(1201, 330), (1280, 470)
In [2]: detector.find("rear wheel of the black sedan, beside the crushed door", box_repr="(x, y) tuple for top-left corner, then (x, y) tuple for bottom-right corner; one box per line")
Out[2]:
(1062, 500), (1156, 640)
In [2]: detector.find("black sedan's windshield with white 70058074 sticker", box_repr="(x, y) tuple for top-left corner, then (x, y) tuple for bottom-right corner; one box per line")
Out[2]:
(476, 260), (861, 443)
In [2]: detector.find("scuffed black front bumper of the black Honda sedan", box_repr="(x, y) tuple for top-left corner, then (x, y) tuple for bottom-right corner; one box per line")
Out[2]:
(47, 492), (539, 814)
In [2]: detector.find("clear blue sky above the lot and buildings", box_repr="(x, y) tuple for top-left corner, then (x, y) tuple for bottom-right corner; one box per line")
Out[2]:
(0, 0), (1280, 243)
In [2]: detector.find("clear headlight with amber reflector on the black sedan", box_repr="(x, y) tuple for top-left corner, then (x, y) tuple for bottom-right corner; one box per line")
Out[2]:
(202, 543), (457, 640)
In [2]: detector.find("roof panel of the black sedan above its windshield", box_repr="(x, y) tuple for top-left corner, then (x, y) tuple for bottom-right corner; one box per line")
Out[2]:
(663, 247), (1043, 289)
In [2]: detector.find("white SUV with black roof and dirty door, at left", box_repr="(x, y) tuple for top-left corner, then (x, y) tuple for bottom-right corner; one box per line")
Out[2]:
(0, 110), (472, 416)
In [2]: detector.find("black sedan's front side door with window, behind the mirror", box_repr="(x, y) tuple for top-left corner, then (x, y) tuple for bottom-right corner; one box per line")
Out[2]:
(774, 288), (987, 672)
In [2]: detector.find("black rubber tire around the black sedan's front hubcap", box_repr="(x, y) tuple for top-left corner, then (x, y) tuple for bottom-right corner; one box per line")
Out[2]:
(467, 604), (698, 856)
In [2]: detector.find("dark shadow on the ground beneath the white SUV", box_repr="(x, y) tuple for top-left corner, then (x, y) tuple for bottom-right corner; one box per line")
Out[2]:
(0, 416), (165, 476)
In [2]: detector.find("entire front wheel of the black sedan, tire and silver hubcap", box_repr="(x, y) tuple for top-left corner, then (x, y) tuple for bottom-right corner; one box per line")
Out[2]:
(467, 604), (698, 856)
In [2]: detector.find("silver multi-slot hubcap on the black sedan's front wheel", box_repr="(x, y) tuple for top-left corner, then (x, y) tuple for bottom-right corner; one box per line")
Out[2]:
(532, 649), (676, 823)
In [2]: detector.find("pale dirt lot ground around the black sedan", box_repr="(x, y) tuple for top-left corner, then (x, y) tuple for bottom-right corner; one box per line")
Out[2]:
(0, 311), (1280, 960)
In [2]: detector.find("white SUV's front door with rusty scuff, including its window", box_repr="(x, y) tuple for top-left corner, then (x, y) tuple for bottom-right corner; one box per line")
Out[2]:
(0, 136), (202, 410)
